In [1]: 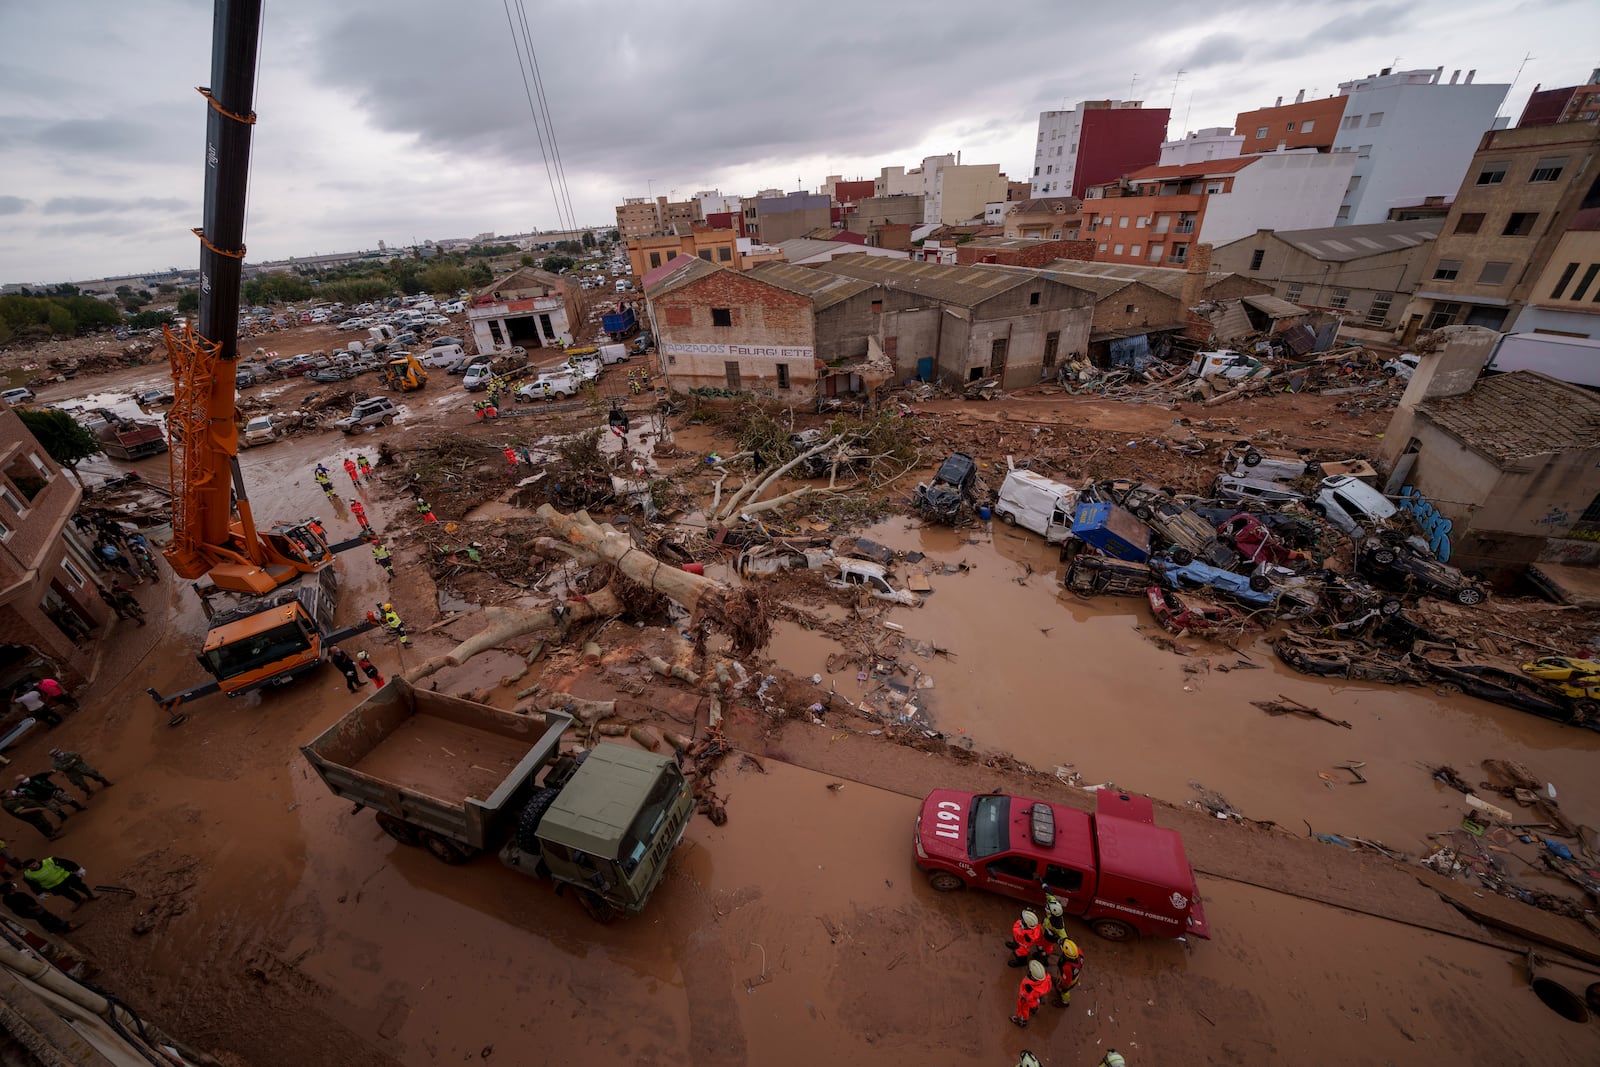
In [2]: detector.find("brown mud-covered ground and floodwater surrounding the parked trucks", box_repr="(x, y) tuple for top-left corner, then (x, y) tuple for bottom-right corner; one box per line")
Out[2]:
(8, 326), (1600, 1067)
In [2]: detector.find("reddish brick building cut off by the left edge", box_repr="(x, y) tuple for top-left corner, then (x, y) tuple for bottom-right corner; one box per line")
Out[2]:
(0, 408), (112, 683)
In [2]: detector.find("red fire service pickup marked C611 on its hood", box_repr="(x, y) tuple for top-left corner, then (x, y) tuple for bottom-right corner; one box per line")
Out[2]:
(917, 789), (1211, 941)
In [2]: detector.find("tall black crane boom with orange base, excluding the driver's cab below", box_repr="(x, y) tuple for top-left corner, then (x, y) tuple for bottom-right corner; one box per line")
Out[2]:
(166, 0), (331, 593)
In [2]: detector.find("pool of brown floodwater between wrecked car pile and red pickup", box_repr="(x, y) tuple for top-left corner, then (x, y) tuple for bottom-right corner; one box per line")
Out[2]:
(771, 518), (1600, 853)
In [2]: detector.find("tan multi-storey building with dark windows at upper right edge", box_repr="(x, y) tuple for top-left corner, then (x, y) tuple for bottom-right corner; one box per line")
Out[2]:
(1405, 122), (1600, 342)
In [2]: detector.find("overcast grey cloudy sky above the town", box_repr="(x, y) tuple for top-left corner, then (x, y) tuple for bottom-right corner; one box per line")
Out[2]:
(0, 0), (1600, 282)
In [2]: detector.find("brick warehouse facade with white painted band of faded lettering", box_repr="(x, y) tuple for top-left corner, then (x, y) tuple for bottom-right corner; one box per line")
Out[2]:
(643, 256), (832, 402)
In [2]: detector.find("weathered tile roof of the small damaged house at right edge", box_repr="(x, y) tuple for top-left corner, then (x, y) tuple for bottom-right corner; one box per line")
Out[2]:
(1418, 371), (1600, 464)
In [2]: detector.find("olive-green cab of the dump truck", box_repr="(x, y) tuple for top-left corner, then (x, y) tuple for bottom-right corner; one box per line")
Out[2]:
(501, 745), (694, 918)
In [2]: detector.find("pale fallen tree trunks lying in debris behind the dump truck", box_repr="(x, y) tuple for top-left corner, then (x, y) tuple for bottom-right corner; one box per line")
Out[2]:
(405, 504), (771, 681)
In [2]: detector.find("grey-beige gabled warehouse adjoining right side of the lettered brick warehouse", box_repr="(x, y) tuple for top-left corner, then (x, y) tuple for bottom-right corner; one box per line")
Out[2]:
(816, 256), (1094, 389)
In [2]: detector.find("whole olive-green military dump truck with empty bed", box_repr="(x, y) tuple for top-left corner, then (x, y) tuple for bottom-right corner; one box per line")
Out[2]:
(301, 678), (694, 921)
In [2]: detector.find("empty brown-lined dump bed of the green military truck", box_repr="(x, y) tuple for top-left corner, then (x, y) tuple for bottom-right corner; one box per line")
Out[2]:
(301, 678), (573, 849)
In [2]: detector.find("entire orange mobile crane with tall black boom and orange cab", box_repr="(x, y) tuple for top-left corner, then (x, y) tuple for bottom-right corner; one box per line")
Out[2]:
(149, 0), (368, 721)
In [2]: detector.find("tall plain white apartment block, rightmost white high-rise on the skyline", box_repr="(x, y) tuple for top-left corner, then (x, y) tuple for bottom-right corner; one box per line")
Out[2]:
(1333, 67), (1510, 226)
